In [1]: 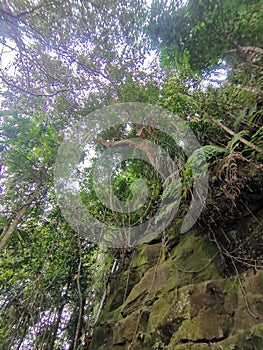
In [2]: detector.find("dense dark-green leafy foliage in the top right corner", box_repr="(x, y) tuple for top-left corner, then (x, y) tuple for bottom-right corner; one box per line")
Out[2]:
(150, 0), (262, 71)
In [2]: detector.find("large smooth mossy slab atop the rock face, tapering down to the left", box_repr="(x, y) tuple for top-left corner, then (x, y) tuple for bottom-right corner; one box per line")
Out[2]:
(123, 232), (222, 314)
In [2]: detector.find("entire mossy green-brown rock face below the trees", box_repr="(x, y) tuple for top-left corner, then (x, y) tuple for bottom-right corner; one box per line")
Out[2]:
(90, 220), (263, 350)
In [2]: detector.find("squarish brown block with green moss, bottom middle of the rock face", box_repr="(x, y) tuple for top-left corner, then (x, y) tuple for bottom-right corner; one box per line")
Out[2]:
(167, 280), (234, 348)
